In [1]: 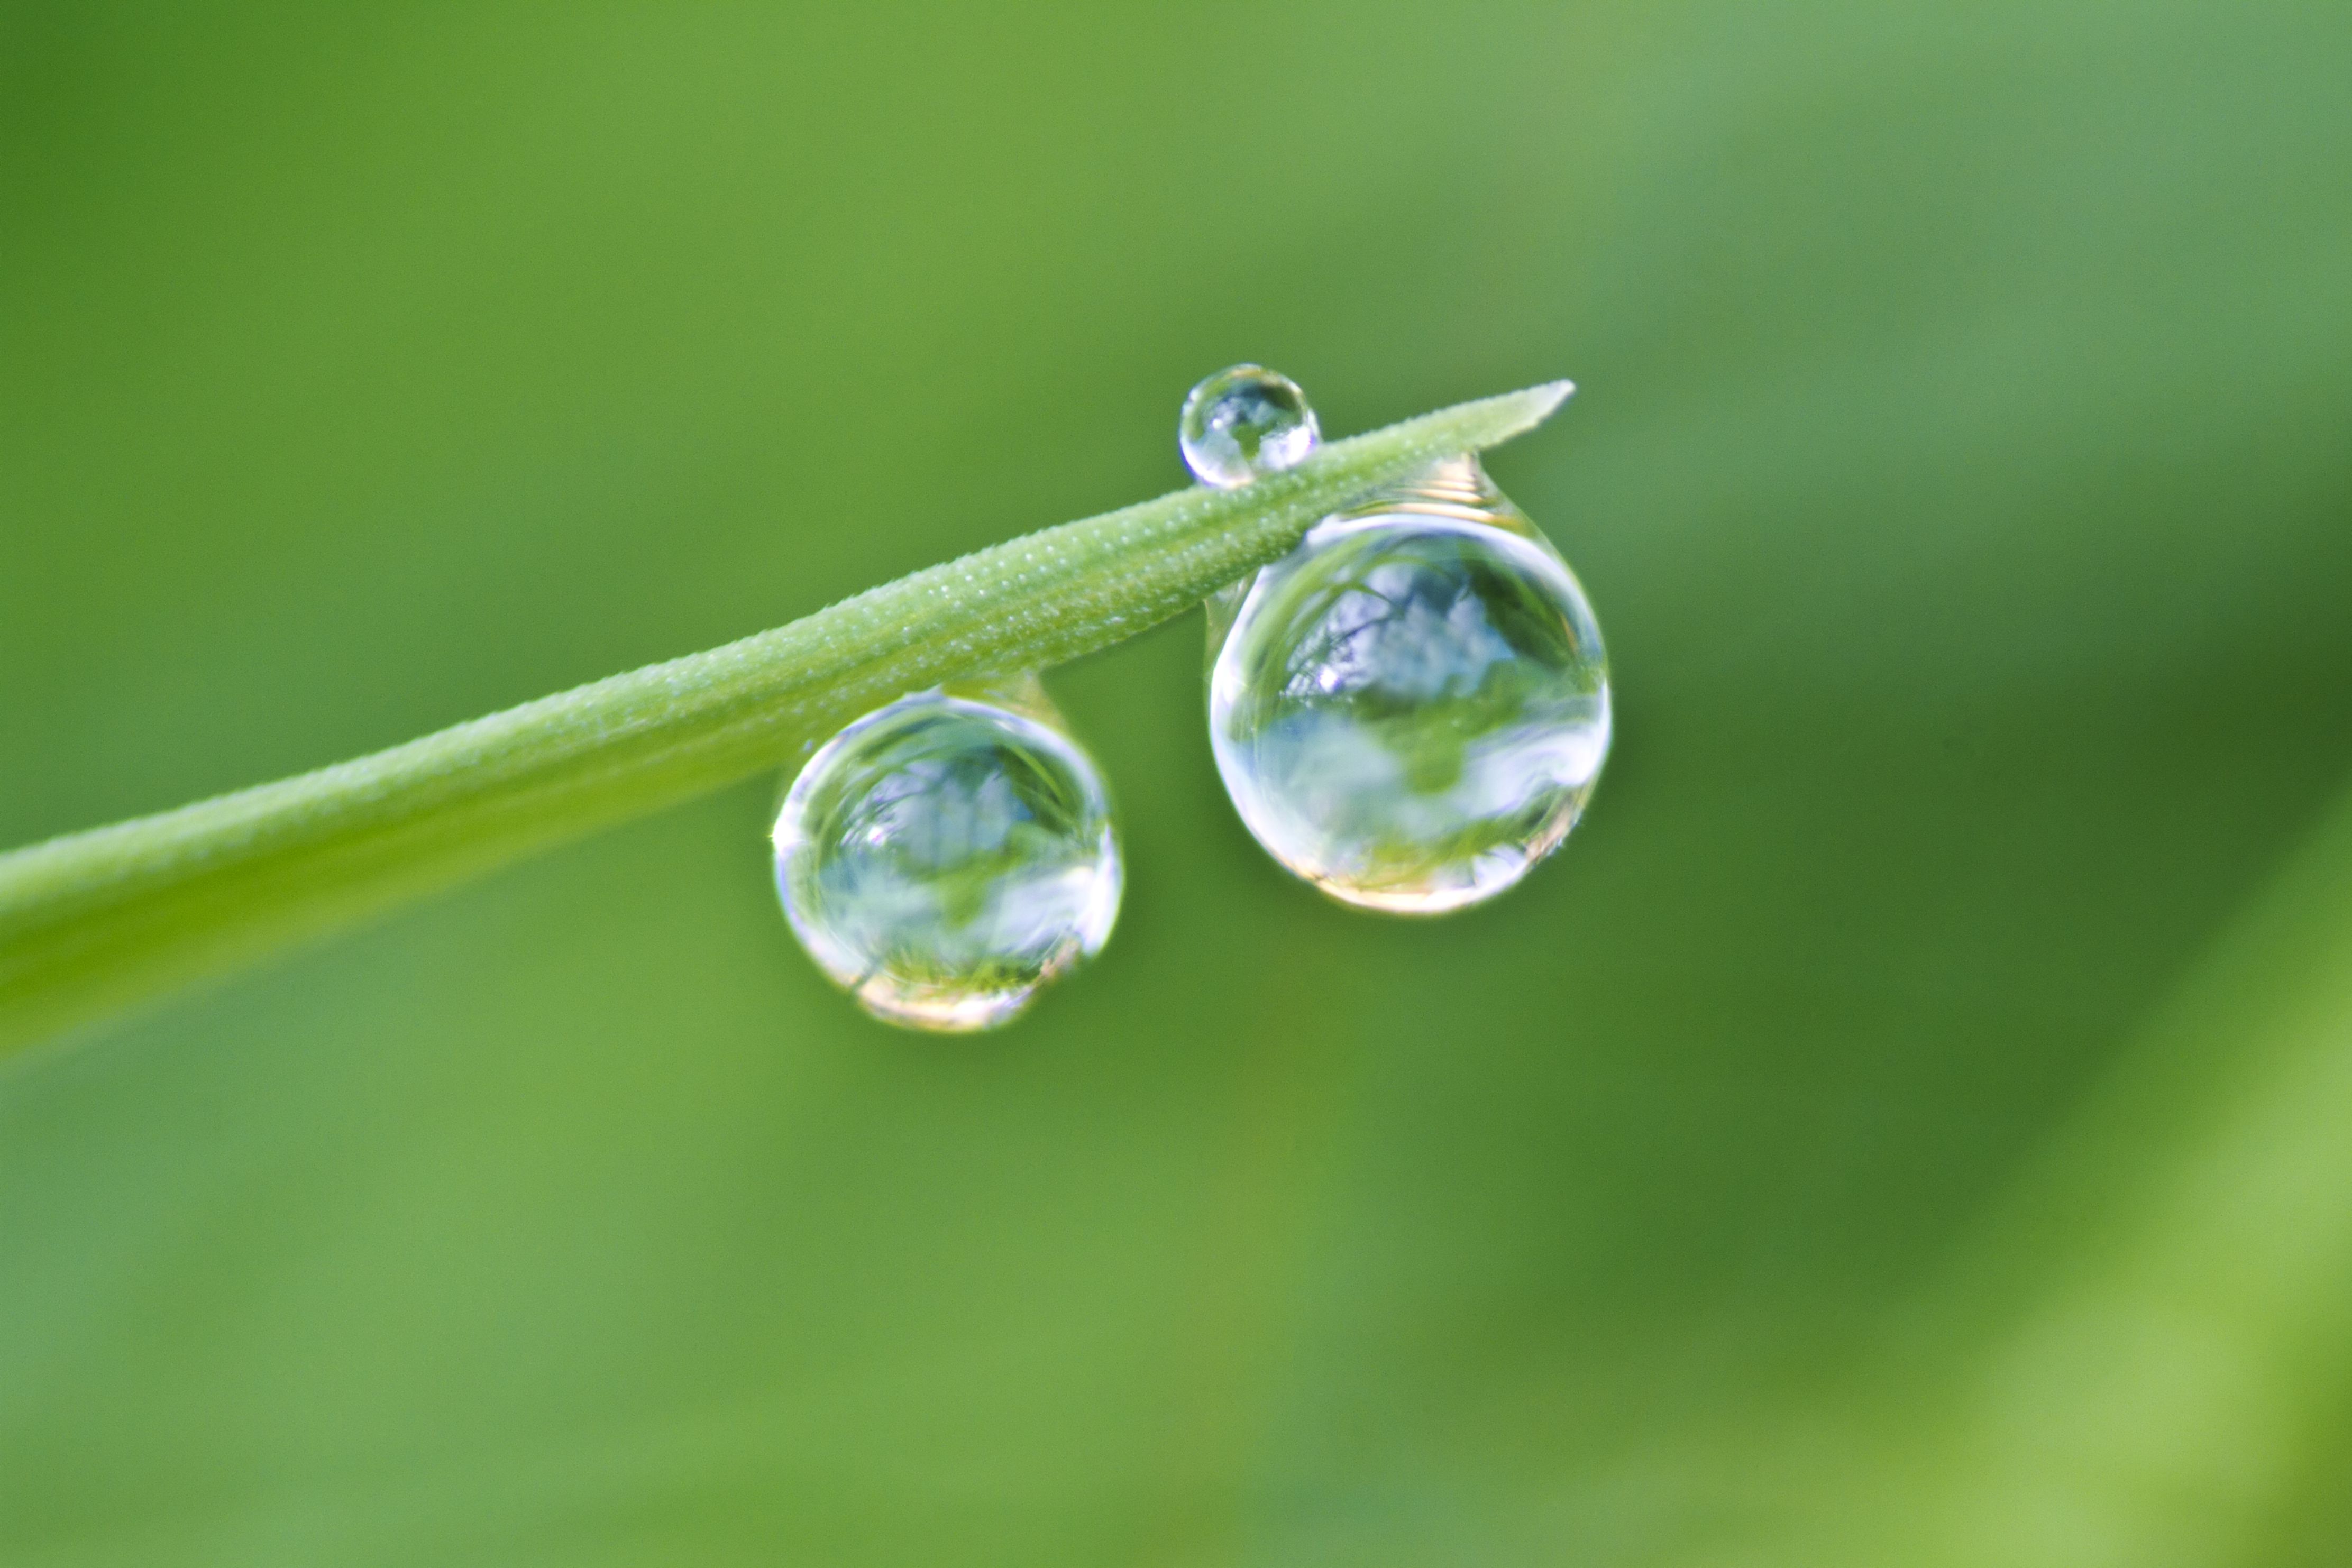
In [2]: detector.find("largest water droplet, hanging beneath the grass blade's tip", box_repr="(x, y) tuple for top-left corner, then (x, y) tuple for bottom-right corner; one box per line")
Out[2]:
(1209, 459), (1609, 914)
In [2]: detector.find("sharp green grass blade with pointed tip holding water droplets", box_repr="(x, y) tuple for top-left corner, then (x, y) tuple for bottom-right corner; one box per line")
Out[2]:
(0, 381), (1569, 1053)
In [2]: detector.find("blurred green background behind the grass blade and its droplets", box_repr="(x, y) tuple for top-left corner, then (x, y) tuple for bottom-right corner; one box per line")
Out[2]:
(0, 0), (2352, 1568)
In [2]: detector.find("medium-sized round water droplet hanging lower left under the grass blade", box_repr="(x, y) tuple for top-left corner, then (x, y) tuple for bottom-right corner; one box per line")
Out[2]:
(776, 686), (1122, 1032)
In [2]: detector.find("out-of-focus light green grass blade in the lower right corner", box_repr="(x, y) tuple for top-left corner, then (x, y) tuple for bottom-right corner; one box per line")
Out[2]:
(1891, 797), (2352, 1568)
